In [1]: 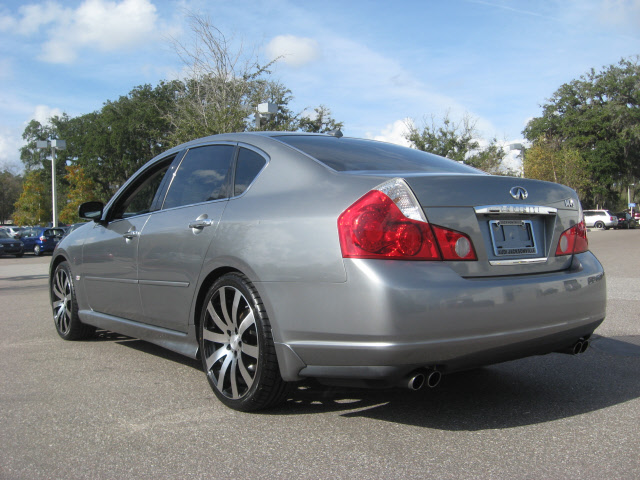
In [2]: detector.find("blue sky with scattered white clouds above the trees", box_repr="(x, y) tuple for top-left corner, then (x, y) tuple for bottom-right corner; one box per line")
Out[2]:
(0, 0), (640, 173)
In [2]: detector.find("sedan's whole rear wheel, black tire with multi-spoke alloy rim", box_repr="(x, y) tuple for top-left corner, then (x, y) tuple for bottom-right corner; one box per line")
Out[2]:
(199, 273), (289, 412)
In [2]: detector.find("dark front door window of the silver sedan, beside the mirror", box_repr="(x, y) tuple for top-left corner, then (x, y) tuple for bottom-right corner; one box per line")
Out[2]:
(109, 157), (175, 220)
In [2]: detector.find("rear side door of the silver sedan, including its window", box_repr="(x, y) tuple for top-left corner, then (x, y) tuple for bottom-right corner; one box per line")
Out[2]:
(138, 143), (235, 332)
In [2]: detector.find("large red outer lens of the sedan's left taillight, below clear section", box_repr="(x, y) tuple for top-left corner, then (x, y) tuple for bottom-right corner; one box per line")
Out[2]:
(338, 190), (440, 260)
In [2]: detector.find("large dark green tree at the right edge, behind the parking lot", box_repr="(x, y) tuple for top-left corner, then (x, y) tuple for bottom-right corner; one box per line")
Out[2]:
(523, 57), (640, 206)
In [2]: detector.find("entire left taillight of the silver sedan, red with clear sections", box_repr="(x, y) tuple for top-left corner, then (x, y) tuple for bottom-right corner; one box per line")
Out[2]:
(338, 178), (476, 260)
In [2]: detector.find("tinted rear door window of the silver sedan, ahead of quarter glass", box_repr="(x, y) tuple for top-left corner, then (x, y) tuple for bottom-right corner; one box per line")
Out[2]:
(163, 145), (235, 209)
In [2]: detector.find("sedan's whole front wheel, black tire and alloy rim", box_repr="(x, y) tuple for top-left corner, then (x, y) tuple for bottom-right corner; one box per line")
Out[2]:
(50, 262), (96, 340)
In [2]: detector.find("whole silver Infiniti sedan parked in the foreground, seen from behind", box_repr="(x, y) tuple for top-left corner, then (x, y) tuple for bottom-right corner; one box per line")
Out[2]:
(50, 132), (606, 411)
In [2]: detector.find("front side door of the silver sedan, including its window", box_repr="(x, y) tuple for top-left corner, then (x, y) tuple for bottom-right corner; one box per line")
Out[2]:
(81, 157), (173, 321)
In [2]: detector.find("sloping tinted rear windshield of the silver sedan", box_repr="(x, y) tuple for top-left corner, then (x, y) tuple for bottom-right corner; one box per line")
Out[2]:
(277, 135), (481, 174)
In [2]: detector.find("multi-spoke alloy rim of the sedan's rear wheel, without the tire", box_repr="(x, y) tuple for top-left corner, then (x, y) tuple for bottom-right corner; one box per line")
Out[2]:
(202, 286), (260, 400)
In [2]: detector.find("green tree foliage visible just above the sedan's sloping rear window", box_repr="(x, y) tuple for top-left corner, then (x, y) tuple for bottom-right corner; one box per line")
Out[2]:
(405, 113), (510, 174)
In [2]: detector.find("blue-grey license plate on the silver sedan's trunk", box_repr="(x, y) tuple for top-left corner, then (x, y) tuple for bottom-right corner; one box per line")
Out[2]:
(489, 220), (538, 257)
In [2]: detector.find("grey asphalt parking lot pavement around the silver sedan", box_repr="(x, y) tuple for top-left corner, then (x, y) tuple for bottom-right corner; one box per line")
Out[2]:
(0, 229), (640, 480)
